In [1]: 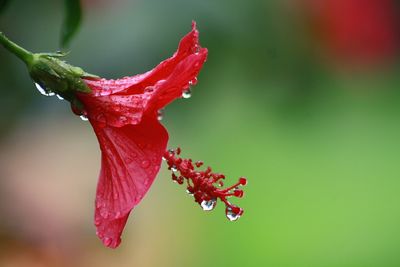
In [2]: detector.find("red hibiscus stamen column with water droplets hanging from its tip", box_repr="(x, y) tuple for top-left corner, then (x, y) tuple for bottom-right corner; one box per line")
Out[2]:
(164, 147), (247, 221)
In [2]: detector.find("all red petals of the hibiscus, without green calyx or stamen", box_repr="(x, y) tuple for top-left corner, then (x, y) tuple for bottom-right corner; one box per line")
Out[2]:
(78, 23), (222, 248)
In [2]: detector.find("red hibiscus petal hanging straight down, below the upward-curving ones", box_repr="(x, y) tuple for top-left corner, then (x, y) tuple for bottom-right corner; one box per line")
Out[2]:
(91, 117), (168, 248)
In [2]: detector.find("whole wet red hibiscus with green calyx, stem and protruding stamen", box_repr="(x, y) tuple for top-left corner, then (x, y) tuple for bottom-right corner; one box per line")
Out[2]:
(0, 22), (247, 248)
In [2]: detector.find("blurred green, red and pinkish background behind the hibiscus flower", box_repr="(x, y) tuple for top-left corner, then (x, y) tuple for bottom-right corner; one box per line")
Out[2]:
(0, 0), (400, 267)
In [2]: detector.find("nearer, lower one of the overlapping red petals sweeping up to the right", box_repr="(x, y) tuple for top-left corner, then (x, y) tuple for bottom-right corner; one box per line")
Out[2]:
(80, 45), (207, 127)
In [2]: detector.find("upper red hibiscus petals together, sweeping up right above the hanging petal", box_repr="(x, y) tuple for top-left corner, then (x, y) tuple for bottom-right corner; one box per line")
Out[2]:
(78, 23), (207, 127)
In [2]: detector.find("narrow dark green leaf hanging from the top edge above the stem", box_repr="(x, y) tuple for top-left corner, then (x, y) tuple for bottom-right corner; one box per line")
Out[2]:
(61, 0), (82, 47)
